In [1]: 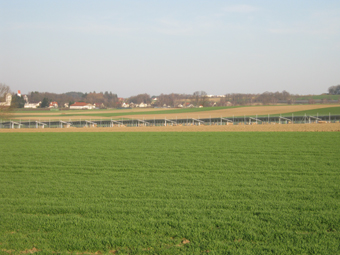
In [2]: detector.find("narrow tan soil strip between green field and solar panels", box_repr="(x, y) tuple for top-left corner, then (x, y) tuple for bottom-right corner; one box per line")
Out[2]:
(0, 123), (340, 133)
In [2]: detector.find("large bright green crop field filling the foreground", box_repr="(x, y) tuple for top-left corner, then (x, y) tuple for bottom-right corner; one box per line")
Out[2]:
(0, 132), (340, 254)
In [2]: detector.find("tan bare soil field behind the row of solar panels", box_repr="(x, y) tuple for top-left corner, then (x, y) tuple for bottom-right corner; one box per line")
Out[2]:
(13, 104), (340, 120)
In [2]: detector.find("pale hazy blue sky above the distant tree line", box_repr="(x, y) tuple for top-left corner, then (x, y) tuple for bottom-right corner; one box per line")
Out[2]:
(0, 0), (340, 97)
